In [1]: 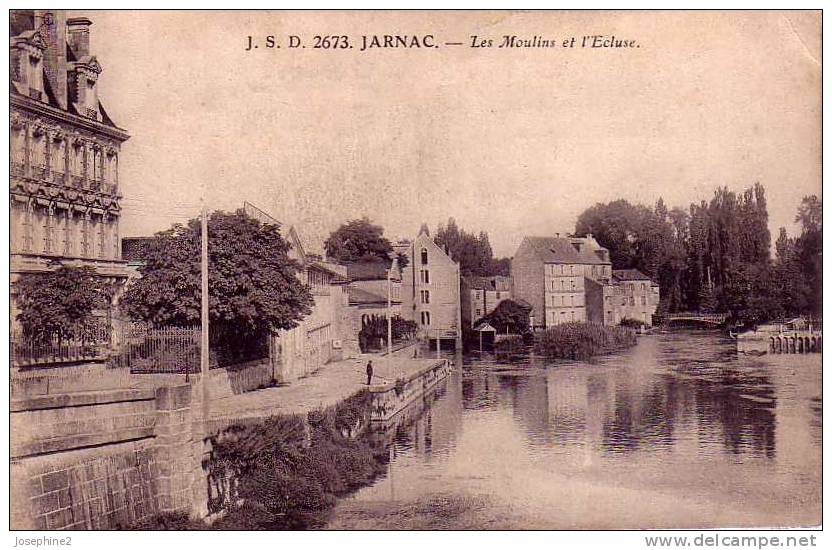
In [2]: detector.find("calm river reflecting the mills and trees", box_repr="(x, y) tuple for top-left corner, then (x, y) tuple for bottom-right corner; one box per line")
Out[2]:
(328, 331), (822, 529)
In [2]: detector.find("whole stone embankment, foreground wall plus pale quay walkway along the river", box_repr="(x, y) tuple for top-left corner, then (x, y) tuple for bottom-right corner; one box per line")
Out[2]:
(10, 348), (450, 529)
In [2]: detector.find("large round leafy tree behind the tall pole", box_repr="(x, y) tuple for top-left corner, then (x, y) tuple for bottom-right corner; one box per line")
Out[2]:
(121, 210), (313, 347)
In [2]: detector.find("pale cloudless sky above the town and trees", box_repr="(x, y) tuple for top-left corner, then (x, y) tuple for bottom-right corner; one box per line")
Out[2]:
(78, 11), (821, 256)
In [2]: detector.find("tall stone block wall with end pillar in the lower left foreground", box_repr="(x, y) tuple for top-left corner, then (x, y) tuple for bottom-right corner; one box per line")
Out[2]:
(10, 385), (207, 530)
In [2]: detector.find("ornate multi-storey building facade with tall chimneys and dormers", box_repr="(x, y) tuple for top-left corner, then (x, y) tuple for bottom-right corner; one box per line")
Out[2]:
(9, 10), (129, 314)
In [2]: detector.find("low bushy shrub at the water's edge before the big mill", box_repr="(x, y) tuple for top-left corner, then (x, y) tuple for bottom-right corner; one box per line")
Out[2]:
(534, 323), (636, 359)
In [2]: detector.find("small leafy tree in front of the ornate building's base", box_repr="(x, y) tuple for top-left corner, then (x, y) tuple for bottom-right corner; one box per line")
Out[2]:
(16, 266), (113, 341)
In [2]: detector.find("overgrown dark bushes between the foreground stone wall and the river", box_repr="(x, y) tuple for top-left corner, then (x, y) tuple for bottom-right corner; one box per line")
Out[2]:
(131, 391), (388, 530)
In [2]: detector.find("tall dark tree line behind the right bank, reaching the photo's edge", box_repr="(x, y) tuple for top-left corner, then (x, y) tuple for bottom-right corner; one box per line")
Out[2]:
(575, 183), (822, 324)
